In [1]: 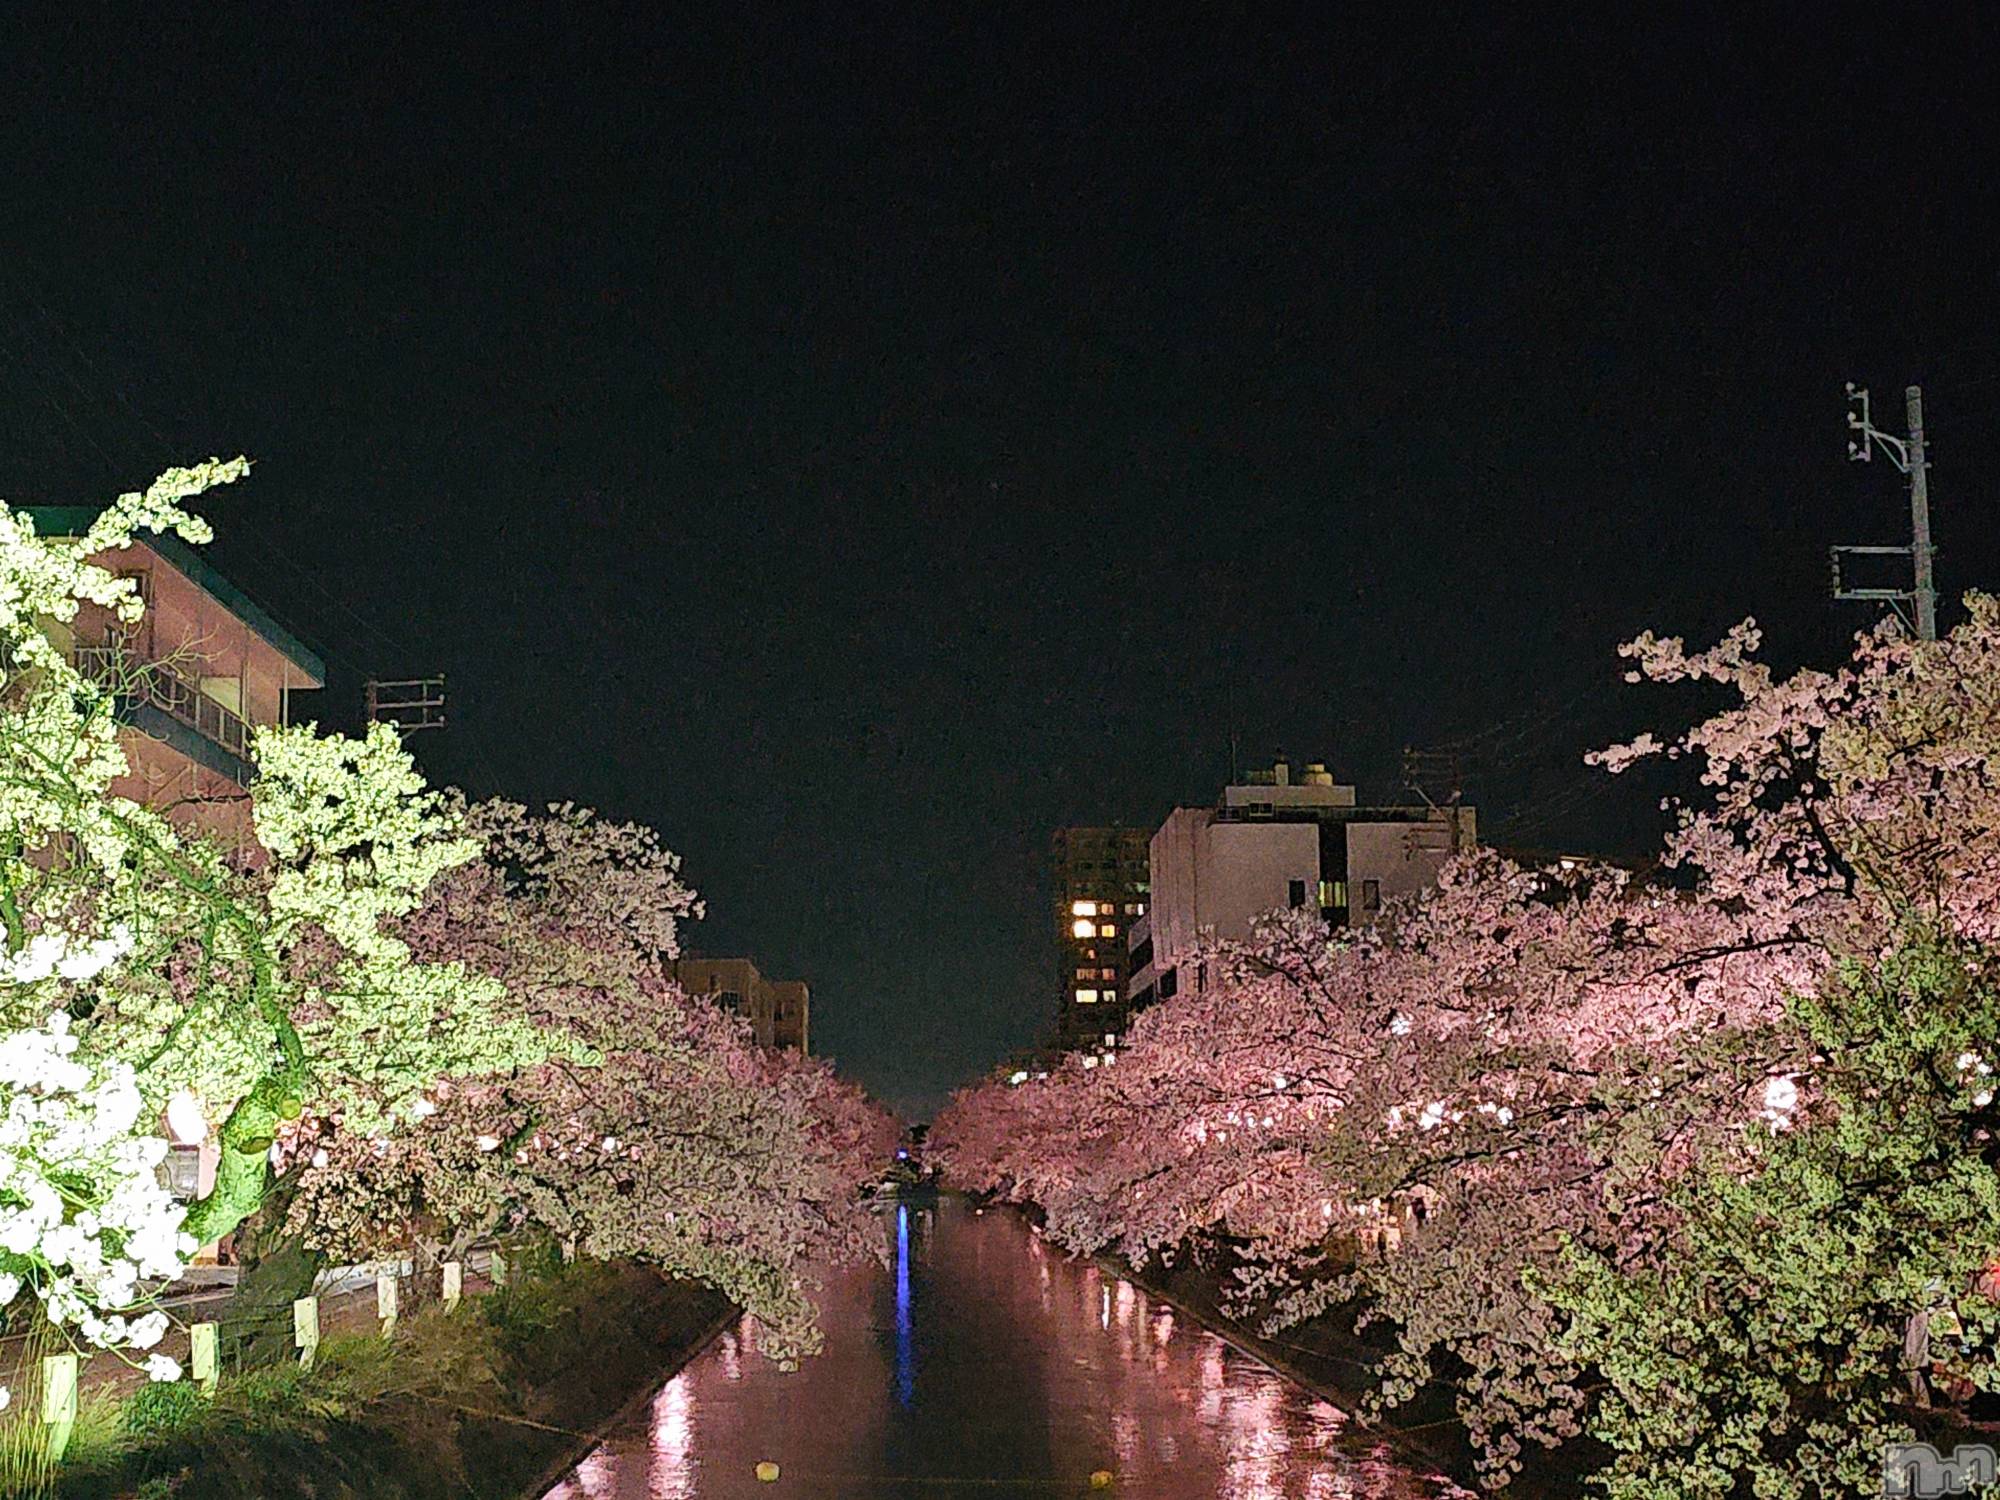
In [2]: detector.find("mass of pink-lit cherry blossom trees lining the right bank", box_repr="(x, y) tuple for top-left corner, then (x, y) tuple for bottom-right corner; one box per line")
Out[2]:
(932, 596), (2000, 1494)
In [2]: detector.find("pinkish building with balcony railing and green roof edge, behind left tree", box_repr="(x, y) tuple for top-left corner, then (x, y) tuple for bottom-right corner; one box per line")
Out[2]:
(28, 506), (326, 848)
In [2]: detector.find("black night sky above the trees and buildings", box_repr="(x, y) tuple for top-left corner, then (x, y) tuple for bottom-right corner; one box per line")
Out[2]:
(0, 4), (2000, 1106)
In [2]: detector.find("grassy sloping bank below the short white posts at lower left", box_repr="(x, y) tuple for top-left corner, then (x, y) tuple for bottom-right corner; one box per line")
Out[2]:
(29, 1266), (738, 1500)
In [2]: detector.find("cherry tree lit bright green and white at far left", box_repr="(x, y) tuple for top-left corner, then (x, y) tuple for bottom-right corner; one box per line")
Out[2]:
(0, 468), (550, 1360)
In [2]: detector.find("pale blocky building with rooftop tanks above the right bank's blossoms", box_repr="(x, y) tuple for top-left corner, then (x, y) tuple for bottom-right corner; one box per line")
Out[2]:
(1126, 760), (1478, 1010)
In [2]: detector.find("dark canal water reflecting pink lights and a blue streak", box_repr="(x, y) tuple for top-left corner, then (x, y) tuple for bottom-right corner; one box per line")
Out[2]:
(548, 1200), (1464, 1500)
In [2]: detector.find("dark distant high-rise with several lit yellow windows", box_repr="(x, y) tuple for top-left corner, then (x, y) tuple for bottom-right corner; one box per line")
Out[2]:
(1050, 828), (1152, 1048)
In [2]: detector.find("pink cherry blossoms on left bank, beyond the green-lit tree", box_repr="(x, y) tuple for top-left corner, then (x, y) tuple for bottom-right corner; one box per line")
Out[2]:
(286, 804), (894, 1354)
